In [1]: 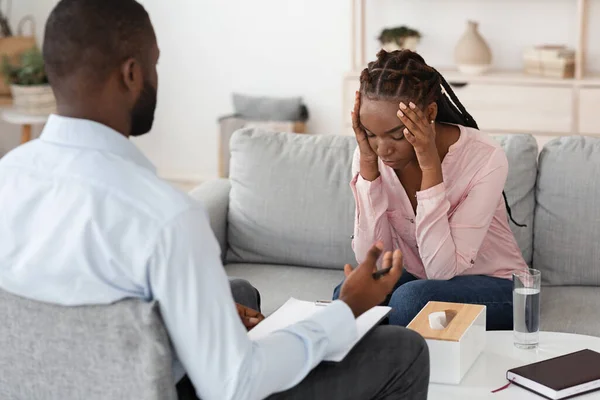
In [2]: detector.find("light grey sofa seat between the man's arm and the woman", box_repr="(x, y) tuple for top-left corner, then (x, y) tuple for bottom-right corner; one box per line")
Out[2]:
(225, 264), (344, 315)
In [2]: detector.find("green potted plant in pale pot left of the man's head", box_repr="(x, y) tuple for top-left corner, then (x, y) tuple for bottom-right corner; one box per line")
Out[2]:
(2, 48), (56, 114)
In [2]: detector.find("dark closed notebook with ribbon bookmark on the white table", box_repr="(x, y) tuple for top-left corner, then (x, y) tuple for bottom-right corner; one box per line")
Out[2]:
(506, 350), (600, 400)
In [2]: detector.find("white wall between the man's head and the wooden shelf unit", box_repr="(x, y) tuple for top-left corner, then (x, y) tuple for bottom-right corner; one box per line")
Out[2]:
(133, 0), (350, 178)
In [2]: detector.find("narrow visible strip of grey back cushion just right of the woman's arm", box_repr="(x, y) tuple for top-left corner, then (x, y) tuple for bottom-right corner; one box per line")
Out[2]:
(496, 135), (538, 265)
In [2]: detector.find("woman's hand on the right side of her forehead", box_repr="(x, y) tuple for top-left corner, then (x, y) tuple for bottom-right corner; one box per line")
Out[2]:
(398, 102), (440, 171)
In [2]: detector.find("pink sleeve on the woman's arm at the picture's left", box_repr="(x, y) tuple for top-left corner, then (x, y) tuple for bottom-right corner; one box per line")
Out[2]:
(350, 148), (393, 264)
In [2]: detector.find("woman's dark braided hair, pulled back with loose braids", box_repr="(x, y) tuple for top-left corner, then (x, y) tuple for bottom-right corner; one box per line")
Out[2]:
(360, 50), (525, 227)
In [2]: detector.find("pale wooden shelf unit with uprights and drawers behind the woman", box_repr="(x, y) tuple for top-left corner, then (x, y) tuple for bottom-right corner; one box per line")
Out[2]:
(343, 0), (600, 143)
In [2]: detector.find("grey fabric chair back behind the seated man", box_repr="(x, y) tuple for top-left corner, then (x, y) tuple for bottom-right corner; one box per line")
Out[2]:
(0, 290), (176, 400)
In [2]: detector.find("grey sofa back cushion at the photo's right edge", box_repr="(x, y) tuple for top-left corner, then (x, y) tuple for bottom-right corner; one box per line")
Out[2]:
(533, 137), (600, 286)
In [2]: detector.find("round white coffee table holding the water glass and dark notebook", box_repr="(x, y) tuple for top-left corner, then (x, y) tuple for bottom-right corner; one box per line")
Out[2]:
(429, 331), (600, 400)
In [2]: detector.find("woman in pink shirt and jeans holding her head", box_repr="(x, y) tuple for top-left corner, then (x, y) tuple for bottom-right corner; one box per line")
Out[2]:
(334, 50), (527, 329)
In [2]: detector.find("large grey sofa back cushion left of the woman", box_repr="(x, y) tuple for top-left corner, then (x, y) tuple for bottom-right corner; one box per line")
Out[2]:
(227, 129), (356, 270)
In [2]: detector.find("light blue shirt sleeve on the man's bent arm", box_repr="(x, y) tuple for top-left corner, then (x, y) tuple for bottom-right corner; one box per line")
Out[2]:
(148, 208), (357, 400)
